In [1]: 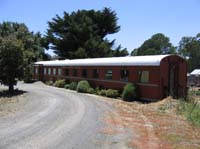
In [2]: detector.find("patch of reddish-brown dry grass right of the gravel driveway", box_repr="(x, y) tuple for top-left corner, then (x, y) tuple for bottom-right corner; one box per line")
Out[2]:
(103, 97), (200, 149)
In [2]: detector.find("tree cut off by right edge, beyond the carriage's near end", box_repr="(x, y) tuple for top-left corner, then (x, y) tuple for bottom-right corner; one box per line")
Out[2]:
(178, 33), (200, 72)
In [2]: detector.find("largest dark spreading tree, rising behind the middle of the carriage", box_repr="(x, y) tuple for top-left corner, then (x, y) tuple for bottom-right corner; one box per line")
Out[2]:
(46, 8), (127, 59)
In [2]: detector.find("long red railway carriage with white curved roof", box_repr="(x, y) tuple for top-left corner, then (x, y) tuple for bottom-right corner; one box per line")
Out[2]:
(34, 55), (187, 100)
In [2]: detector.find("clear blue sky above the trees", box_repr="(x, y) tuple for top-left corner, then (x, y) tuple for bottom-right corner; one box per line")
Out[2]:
(0, 0), (200, 52)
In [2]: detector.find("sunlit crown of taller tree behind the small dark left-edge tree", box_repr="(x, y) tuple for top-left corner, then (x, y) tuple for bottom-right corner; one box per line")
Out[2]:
(0, 22), (47, 63)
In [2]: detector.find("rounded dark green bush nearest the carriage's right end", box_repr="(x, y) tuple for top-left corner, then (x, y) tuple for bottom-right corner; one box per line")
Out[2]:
(122, 83), (137, 101)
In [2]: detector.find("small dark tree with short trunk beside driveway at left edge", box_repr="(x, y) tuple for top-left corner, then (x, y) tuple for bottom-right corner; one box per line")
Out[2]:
(0, 37), (24, 92)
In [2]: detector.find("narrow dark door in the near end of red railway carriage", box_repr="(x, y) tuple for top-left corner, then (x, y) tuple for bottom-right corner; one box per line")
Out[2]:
(169, 63), (178, 97)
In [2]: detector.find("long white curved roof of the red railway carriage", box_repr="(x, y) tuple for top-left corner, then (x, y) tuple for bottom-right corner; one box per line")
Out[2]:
(35, 55), (169, 66)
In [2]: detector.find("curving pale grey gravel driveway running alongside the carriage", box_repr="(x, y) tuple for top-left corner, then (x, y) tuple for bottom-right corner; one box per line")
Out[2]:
(0, 82), (131, 149)
